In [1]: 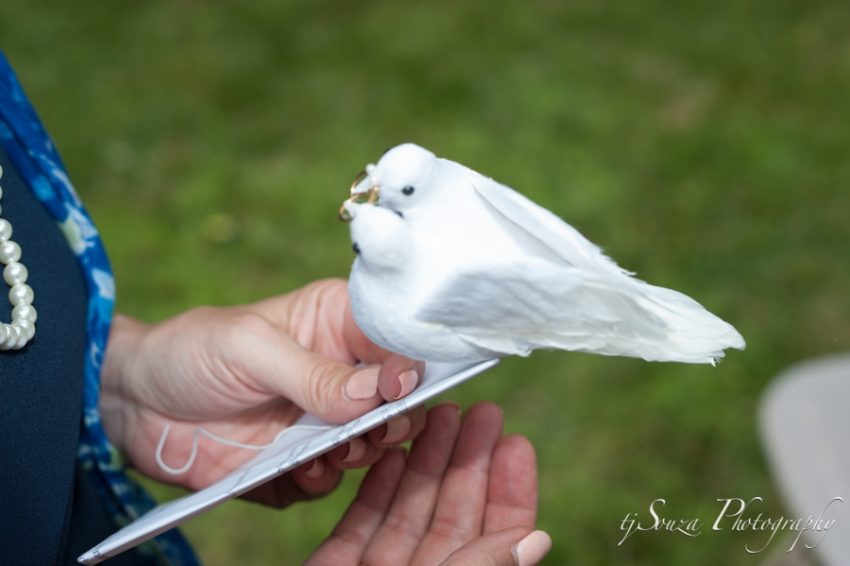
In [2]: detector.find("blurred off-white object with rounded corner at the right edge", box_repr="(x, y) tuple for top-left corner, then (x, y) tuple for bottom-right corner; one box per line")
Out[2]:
(759, 354), (850, 566)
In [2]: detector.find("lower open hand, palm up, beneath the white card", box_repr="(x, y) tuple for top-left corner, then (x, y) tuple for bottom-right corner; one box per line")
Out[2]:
(307, 403), (551, 566)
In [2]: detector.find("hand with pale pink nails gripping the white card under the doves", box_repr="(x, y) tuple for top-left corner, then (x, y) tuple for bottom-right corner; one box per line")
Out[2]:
(100, 280), (425, 507)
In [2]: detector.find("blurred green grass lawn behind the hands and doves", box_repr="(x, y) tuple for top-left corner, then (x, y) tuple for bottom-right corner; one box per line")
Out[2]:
(0, 0), (850, 565)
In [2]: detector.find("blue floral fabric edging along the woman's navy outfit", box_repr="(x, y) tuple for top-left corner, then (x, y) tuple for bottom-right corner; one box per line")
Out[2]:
(0, 52), (198, 565)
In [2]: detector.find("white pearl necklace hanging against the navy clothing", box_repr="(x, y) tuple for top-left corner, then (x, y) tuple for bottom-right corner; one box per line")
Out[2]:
(0, 167), (37, 350)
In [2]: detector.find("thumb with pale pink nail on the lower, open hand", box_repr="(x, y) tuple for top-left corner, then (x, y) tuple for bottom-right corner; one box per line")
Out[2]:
(443, 527), (552, 566)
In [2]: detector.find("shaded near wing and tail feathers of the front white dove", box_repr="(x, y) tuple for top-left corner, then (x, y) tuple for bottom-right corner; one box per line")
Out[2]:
(414, 258), (743, 363)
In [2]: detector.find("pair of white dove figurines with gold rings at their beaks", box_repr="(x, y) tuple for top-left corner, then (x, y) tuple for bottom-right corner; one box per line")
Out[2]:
(340, 143), (745, 364)
